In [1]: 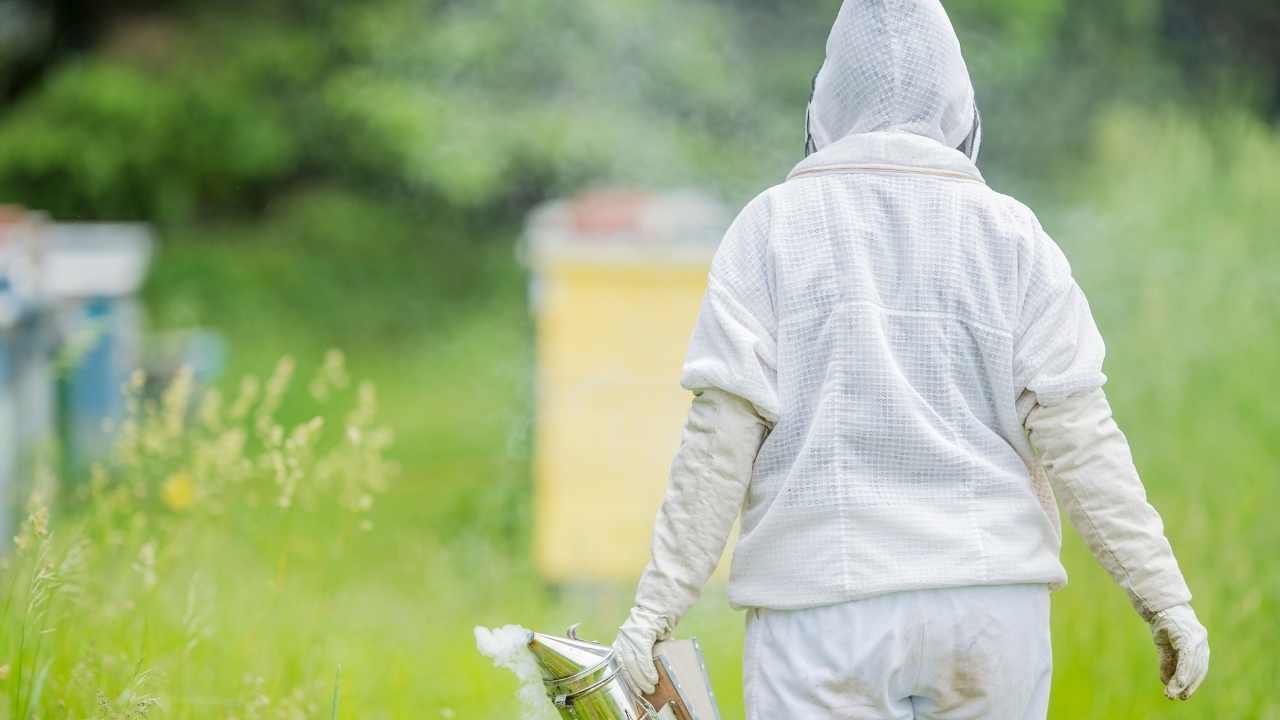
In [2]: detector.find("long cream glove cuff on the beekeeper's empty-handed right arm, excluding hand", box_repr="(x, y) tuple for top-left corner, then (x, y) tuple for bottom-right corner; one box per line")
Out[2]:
(1025, 388), (1192, 621)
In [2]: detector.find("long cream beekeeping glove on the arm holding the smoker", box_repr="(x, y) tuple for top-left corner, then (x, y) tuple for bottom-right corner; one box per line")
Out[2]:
(613, 389), (769, 694)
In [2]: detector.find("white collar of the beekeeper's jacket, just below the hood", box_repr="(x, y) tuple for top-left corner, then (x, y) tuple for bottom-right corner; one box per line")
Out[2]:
(787, 131), (986, 183)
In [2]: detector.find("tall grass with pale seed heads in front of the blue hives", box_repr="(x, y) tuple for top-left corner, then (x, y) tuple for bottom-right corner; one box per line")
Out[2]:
(0, 352), (397, 719)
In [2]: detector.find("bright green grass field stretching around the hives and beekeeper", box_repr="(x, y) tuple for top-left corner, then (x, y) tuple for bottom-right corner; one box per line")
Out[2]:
(0, 107), (1280, 720)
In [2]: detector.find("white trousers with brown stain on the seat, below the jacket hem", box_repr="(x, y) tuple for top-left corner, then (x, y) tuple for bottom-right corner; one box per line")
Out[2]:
(742, 585), (1053, 720)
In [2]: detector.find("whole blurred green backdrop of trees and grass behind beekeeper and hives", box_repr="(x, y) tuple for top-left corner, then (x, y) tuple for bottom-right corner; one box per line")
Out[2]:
(0, 0), (1280, 719)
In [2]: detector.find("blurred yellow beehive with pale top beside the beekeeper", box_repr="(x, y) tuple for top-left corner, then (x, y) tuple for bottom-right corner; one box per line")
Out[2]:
(526, 191), (727, 582)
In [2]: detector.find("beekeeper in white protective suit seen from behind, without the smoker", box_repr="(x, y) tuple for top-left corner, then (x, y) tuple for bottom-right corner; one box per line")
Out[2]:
(614, 0), (1208, 720)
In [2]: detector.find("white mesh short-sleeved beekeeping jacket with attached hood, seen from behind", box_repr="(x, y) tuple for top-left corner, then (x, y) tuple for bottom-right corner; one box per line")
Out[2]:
(682, 0), (1105, 609)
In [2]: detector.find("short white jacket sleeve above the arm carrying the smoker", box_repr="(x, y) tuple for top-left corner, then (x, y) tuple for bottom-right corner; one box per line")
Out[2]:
(681, 196), (781, 423)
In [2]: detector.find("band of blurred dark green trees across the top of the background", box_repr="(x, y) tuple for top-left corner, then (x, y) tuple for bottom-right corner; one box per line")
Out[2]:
(0, 0), (1275, 223)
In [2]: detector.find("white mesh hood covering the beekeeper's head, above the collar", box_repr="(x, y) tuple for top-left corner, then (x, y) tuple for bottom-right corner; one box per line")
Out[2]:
(808, 0), (980, 159)
